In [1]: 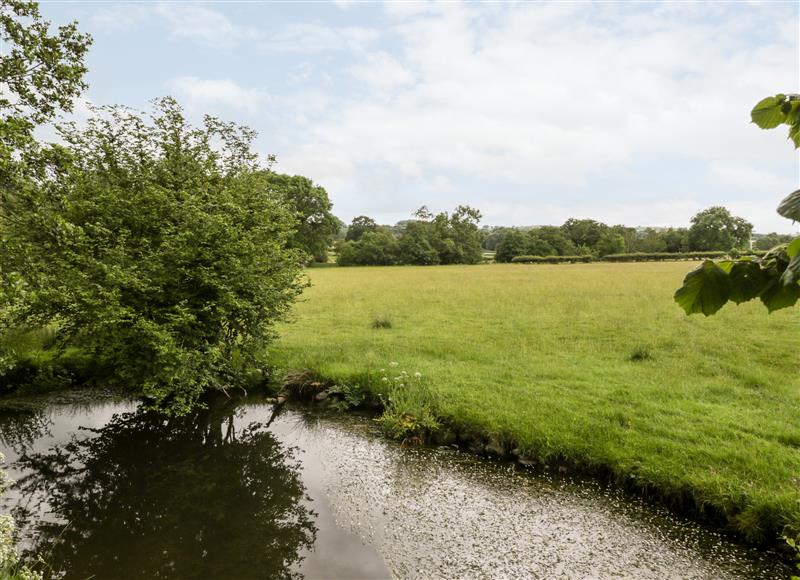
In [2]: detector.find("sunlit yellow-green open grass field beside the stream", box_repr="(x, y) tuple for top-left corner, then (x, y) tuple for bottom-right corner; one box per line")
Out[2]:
(271, 262), (800, 541)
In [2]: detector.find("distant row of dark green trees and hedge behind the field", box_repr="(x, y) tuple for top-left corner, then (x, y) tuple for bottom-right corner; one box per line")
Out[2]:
(336, 206), (792, 266)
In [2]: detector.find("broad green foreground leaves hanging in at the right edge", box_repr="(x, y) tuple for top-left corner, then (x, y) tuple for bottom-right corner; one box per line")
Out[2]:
(675, 94), (800, 316)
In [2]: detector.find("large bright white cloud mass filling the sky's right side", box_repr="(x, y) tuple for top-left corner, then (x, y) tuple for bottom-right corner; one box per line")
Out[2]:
(274, 3), (800, 225)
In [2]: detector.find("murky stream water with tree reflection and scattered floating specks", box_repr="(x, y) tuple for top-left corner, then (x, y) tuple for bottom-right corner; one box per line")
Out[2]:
(0, 396), (788, 579)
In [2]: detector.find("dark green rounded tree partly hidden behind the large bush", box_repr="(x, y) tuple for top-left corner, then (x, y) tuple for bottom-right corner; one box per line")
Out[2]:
(263, 171), (341, 262)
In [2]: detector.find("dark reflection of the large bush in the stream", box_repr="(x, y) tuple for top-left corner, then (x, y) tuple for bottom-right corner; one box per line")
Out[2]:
(16, 399), (316, 578)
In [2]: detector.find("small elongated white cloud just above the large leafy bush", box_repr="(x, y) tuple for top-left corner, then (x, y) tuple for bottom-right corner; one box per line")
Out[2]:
(168, 76), (270, 113)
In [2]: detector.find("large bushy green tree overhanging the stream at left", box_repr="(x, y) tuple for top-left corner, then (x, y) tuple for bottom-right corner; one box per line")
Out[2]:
(0, 99), (303, 412)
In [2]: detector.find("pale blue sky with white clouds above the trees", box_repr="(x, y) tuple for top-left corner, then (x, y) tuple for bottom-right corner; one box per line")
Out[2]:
(36, 0), (800, 233)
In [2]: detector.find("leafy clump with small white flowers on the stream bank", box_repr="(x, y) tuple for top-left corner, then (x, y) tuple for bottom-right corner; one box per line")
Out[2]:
(375, 362), (441, 444)
